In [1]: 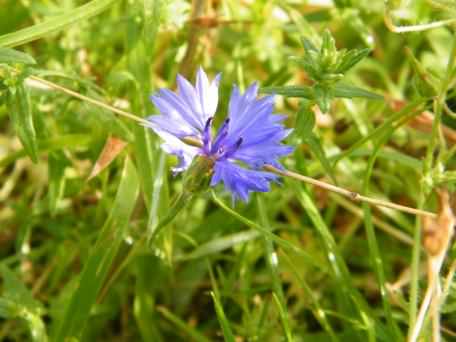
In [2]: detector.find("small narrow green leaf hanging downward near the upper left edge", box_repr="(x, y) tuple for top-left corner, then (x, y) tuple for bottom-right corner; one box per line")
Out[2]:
(8, 84), (38, 163)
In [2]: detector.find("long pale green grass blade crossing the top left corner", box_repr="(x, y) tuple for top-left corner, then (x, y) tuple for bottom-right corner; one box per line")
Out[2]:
(0, 0), (117, 47)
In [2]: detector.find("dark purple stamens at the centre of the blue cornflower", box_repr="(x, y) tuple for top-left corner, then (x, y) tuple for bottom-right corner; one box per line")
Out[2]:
(202, 117), (244, 161)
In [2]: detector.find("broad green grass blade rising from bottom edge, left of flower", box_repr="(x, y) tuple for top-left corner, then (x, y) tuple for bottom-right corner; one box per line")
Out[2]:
(55, 158), (139, 341)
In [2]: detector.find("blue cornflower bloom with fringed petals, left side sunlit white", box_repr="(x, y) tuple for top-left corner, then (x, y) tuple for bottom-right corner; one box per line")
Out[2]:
(148, 68), (293, 202)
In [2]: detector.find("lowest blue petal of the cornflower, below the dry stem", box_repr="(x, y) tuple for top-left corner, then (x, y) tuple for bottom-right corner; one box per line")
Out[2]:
(211, 161), (278, 202)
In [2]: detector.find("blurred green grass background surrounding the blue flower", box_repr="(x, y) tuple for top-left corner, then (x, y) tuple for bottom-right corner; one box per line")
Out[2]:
(0, 0), (456, 342)
